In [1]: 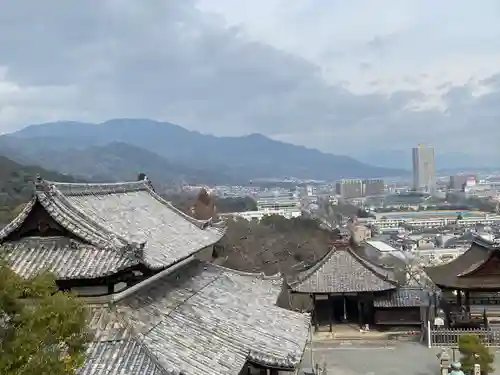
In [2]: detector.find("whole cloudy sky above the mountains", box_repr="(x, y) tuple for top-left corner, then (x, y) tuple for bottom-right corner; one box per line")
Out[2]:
(0, 0), (500, 161)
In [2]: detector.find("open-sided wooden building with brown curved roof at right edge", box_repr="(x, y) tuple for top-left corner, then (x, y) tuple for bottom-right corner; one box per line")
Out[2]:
(425, 236), (500, 326)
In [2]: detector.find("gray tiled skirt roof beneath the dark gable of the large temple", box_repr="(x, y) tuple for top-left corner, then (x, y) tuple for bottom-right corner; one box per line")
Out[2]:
(0, 237), (138, 280)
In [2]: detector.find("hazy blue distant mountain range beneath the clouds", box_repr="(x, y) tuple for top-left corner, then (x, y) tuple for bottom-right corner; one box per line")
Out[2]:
(0, 119), (408, 184)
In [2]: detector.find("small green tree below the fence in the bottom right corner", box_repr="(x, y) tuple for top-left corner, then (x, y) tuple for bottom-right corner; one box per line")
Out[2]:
(458, 335), (495, 375)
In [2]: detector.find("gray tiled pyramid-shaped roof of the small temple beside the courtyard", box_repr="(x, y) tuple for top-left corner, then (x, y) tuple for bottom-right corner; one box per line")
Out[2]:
(290, 248), (398, 293)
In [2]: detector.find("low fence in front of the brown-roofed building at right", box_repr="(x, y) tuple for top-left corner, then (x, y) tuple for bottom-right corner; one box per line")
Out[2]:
(427, 325), (500, 348)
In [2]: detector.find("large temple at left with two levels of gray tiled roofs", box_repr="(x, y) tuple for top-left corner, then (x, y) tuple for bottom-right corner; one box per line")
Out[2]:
(0, 177), (311, 375)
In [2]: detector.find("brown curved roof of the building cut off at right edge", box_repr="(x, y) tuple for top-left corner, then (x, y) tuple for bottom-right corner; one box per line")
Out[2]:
(425, 236), (500, 290)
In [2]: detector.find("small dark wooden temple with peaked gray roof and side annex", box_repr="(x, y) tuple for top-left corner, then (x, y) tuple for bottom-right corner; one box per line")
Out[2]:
(290, 247), (429, 331)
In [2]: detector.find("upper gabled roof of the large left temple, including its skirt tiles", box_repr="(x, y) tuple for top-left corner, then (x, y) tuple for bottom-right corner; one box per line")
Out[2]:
(0, 178), (224, 278)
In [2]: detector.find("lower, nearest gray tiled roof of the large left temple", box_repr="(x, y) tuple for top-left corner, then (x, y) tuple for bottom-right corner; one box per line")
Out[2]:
(79, 260), (310, 375)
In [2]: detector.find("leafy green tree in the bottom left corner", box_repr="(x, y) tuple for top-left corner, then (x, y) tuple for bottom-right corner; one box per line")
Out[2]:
(0, 262), (90, 375)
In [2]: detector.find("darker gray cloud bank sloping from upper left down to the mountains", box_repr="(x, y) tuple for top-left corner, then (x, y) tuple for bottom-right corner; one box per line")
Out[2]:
(0, 0), (500, 160)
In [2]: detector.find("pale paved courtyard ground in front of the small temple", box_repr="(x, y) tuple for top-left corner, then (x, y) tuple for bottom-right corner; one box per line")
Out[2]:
(303, 340), (500, 375)
